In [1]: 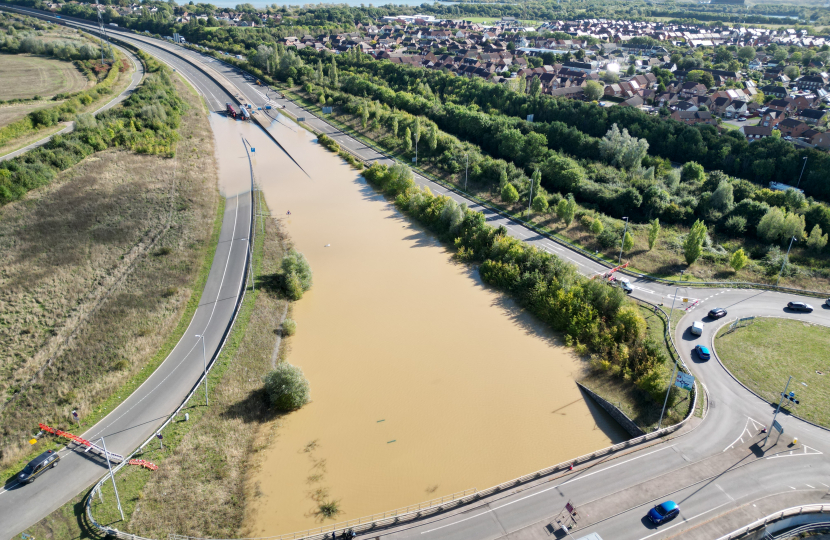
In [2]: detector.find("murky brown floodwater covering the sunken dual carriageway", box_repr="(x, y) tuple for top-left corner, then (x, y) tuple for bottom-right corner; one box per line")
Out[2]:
(208, 113), (627, 536)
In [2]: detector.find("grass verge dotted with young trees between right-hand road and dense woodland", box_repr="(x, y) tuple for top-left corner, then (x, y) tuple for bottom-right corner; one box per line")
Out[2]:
(286, 88), (827, 291)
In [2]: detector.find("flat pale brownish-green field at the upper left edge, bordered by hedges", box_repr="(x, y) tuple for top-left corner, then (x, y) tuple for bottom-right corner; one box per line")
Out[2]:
(0, 54), (92, 100)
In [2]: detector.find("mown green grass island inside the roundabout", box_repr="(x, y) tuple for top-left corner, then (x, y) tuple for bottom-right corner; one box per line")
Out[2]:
(715, 318), (830, 427)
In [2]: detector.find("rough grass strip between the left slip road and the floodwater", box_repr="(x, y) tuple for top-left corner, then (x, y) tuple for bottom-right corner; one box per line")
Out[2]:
(27, 194), (287, 538)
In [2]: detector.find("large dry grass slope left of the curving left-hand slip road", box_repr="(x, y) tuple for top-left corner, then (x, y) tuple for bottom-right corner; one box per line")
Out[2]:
(0, 68), (218, 481)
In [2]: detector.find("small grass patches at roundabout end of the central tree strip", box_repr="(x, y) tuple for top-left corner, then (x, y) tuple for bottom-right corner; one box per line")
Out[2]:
(579, 306), (703, 433)
